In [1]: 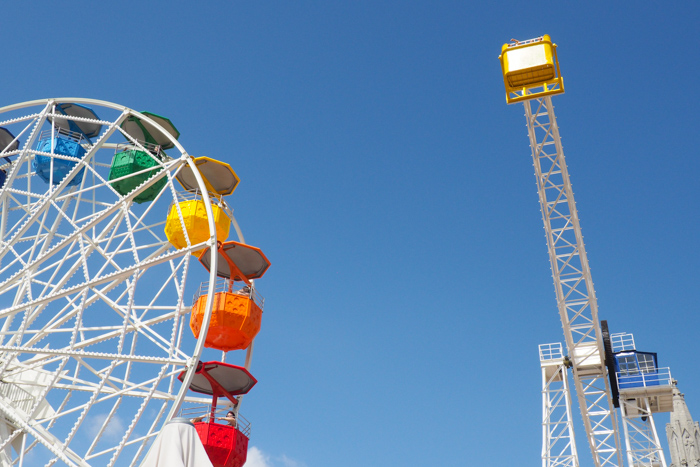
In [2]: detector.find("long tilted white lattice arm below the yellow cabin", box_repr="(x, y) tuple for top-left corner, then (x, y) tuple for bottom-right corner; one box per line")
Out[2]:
(523, 96), (622, 467)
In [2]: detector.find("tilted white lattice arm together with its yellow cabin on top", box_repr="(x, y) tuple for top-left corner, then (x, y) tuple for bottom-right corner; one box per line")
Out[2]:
(499, 35), (622, 467)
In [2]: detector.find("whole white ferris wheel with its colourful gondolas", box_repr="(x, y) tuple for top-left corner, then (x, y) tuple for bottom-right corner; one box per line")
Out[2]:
(0, 98), (270, 467)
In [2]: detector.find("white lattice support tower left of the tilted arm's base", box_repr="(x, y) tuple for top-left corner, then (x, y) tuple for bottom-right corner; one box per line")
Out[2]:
(540, 342), (579, 467)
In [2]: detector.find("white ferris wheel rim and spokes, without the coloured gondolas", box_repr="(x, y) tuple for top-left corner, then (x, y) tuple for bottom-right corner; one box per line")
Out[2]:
(0, 98), (242, 466)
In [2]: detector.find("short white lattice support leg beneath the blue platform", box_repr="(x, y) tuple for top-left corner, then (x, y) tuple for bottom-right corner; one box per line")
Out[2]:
(620, 398), (666, 467)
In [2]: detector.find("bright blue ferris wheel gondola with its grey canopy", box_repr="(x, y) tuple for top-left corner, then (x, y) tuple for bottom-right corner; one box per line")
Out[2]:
(32, 103), (102, 186)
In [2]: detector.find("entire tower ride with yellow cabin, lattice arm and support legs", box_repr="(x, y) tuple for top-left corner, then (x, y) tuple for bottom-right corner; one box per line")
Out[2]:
(499, 35), (673, 467)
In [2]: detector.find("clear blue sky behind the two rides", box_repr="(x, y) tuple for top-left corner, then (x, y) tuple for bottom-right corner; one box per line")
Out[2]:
(0, 0), (700, 467)
